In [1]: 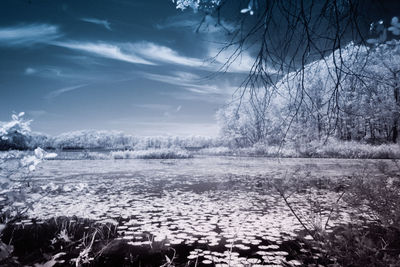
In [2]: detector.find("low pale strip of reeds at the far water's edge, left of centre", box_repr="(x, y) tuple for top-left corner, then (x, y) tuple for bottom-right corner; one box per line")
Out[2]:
(111, 148), (193, 159)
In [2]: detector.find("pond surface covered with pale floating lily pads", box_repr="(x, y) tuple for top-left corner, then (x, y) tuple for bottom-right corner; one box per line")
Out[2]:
(0, 158), (394, 266)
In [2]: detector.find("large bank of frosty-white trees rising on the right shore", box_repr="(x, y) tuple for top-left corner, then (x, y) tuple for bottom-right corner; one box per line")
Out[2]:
(218, 41), (400, 147)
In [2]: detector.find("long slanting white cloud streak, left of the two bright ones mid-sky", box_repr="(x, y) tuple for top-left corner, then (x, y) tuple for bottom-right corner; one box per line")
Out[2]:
(53, 42), (154, 65)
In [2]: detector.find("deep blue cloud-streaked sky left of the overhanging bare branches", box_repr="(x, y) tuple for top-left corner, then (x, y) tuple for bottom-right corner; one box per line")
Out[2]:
(0, 0), (252, 136)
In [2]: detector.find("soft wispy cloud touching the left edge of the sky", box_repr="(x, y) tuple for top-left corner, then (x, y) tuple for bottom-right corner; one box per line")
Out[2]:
(0, 24), (61, 46)
